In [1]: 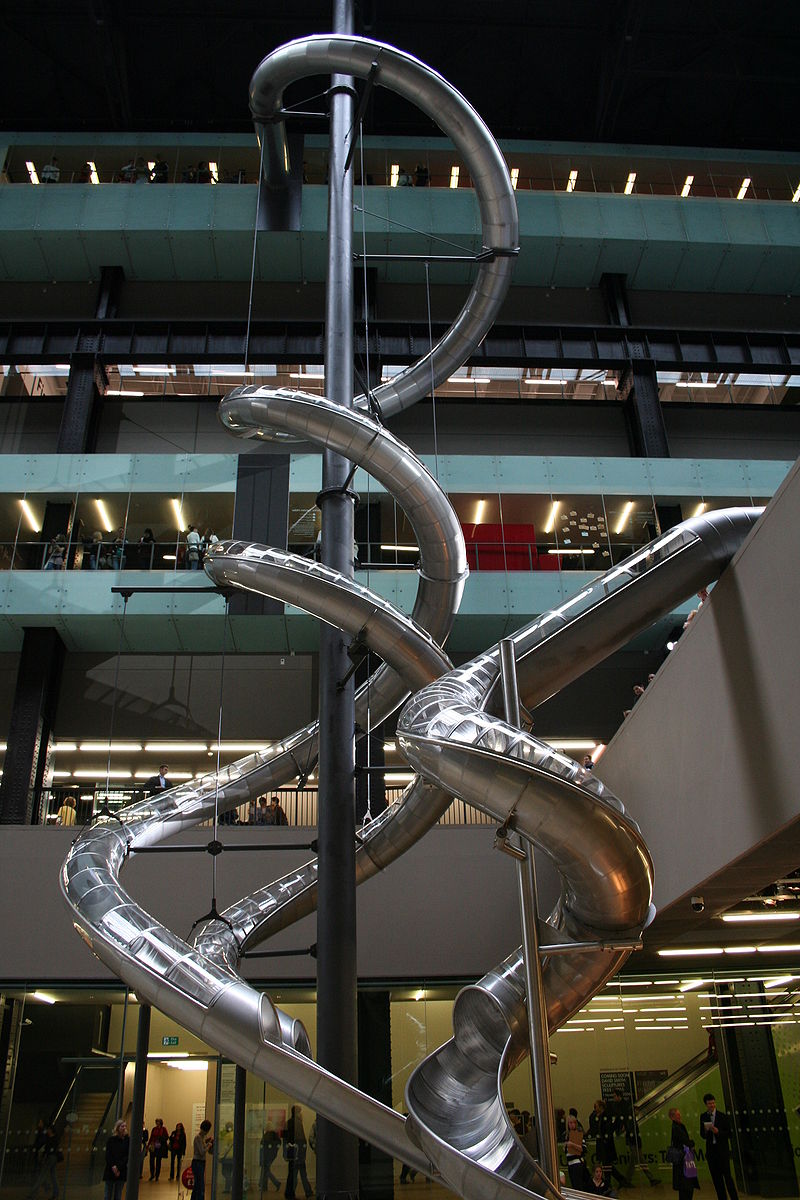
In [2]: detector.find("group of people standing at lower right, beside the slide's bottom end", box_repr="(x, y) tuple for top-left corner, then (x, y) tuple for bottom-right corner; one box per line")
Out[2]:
(561, 1091), (739, 1200)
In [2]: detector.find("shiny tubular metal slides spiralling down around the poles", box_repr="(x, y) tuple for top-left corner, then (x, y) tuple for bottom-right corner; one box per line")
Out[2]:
(61, 30), (758, 1200)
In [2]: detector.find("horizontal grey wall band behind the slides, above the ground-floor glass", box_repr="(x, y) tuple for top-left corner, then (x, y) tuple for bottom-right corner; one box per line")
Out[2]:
(0, 826), (554, 983)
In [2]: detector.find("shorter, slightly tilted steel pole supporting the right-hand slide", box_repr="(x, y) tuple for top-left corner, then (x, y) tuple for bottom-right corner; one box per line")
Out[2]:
(500, 637), (559, 1190)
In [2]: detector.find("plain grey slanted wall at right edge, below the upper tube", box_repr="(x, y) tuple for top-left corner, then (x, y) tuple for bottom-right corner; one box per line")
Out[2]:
(597, 453), (800, 936)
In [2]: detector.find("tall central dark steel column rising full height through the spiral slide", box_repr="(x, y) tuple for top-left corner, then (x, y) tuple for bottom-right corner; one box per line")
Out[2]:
(317, 0), (359, 1198)
